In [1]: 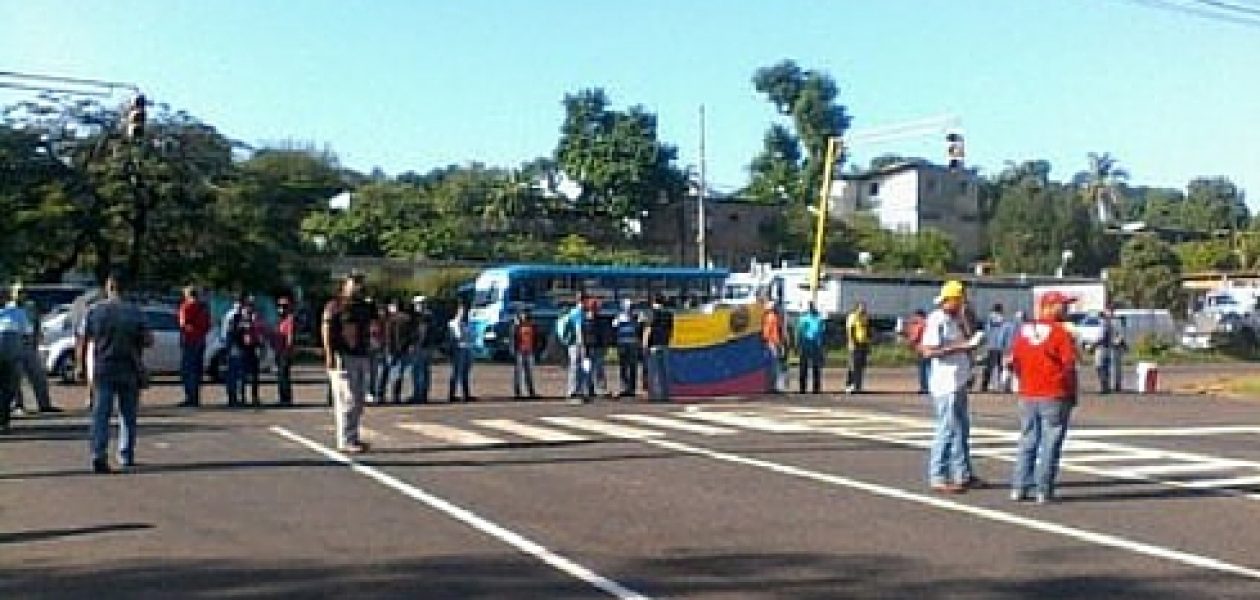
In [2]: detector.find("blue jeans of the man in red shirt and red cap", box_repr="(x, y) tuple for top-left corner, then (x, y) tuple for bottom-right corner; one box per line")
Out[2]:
(1011, 398), (1074, 497)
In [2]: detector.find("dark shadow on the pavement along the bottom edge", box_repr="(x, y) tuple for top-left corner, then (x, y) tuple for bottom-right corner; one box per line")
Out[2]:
(0, 551), (1246, 600)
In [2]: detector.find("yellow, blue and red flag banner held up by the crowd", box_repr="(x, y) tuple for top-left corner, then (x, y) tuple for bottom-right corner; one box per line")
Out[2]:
(669, 306), (774, 397)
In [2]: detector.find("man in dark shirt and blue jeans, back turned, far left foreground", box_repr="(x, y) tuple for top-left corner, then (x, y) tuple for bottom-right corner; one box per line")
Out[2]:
(76, 276), (154, 474)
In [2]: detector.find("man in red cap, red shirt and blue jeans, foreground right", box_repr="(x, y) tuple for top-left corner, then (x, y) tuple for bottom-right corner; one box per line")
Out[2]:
(1011, 291), (1076, 504)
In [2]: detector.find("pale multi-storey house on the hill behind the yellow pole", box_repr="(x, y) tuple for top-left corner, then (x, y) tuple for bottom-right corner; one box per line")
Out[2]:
(829, 163), (985, 262)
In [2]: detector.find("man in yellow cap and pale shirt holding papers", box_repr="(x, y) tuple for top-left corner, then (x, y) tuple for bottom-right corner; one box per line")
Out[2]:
(920, 281), (979, 494)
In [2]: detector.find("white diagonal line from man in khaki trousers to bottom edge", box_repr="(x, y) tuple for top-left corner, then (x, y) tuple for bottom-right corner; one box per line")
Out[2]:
(271, 426), (648, 600)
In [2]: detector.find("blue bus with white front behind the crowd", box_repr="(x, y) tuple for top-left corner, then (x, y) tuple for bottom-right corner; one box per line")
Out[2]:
(470, 265), (730, 358)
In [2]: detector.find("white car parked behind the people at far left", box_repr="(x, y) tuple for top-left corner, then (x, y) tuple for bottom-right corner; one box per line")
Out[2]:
(39, 305), (275, 383)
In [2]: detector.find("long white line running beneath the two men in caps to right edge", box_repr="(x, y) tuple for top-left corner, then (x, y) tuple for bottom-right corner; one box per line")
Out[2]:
(643, 440), (1260, 580)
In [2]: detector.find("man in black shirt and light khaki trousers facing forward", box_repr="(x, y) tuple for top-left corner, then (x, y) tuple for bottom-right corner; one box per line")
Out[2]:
(320, 276), (378, 454)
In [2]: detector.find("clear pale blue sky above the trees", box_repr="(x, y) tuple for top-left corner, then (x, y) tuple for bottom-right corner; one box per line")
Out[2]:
(0, 0), (1260, 207)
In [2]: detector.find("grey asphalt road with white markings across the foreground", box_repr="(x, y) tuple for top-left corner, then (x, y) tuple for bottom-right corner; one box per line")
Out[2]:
(0, 364), (1260, 600)
